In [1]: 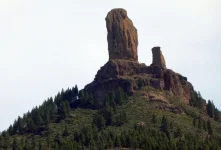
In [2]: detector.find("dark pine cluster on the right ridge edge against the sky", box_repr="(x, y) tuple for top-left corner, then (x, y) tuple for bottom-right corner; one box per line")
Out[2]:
(190, 91), (221, 122)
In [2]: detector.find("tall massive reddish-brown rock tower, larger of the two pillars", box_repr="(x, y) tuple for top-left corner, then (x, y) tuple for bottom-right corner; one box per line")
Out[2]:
(106, 9), (138, 62)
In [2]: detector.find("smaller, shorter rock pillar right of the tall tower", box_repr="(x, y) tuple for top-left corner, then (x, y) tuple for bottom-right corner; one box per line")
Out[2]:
(152, 47), (166, 69)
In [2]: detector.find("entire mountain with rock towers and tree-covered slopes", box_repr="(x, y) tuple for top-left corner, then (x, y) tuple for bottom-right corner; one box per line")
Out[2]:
(0, 9), (221, 150)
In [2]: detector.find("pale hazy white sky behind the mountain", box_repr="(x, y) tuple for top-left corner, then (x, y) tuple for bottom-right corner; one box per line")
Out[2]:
(0, 0), (221, 131)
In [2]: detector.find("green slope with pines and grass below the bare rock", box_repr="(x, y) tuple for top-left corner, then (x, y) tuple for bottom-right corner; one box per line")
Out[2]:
(0, 84), (221, 150)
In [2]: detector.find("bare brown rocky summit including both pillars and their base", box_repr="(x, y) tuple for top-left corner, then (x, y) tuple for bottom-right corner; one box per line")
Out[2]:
(84, 9), (193, 104)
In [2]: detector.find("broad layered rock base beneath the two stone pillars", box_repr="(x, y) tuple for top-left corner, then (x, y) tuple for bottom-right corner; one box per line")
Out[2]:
(85, 59), (193, 104)
